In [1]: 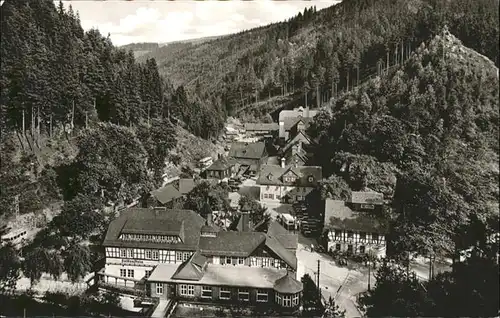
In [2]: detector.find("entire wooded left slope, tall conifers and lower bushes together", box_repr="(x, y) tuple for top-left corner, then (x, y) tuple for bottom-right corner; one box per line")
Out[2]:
(0, 0), (225, 220)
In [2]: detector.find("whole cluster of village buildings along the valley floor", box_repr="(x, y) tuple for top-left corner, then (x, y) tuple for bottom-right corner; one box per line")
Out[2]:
(98, 107), (387, 311)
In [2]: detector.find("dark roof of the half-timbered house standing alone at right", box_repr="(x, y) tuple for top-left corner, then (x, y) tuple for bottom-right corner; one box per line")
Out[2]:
(325, 199), (388, 234)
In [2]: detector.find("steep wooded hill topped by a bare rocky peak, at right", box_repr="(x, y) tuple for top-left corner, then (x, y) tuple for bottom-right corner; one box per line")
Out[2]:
(310, 31), (499, 255)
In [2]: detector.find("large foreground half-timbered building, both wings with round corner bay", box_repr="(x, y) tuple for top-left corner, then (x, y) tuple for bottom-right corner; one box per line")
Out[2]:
(98, 208), (302, 311)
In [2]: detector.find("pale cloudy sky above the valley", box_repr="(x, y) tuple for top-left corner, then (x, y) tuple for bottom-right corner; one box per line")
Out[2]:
(57, 0), (339, 46)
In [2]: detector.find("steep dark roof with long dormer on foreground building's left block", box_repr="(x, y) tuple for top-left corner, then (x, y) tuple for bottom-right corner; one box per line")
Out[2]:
(103, 208), (205, 250)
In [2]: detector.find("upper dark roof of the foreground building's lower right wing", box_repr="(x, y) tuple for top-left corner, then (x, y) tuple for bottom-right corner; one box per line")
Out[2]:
(200, 232), (266, 257)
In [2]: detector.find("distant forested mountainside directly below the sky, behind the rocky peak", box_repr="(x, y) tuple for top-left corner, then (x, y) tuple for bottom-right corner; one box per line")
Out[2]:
(144, 0), (499, 118)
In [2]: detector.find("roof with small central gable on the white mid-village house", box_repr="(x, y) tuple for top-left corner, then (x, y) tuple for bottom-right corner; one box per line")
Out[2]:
(257, 165), (323, 187)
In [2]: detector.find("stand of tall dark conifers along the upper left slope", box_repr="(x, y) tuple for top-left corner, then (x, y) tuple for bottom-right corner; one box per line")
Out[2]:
(0, 0), (222, 137)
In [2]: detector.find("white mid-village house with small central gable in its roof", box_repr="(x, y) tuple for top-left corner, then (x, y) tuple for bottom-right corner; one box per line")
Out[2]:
(257, 164), (322, 203)
